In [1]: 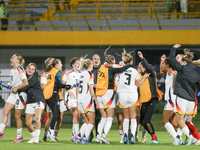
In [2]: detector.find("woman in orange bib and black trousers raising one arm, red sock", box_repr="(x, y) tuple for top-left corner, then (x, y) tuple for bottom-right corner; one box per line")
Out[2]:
(138, 51), (158, 144)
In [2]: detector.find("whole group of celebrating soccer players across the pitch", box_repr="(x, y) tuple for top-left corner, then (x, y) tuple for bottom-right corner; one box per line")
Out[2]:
(0, 44), (200, 145)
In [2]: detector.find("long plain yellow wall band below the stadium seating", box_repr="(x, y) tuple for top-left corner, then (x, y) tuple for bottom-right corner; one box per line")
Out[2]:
(0, 30), (200, 46)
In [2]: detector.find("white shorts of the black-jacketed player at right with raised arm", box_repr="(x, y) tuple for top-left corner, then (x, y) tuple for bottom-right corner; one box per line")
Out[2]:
(175, 96), (196, 115)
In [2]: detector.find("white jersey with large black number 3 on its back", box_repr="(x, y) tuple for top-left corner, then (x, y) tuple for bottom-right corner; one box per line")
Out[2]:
(117, 67), (139, 93)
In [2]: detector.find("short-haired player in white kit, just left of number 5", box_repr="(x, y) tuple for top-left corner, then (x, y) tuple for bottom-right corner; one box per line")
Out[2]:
(63, 57), (80, 142)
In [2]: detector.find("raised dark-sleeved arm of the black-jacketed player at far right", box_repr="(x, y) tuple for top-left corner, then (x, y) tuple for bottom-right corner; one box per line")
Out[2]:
(169, 44), (183, 71)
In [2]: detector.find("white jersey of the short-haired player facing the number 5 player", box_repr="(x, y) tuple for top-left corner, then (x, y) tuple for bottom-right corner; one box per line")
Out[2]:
(63, 71), (80, 98)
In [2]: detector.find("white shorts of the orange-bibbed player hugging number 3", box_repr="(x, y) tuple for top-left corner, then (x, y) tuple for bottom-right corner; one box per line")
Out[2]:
(97, 90), (115, 109)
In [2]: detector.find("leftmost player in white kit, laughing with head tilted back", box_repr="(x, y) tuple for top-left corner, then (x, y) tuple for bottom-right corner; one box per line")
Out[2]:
(0, 54), (28, 143)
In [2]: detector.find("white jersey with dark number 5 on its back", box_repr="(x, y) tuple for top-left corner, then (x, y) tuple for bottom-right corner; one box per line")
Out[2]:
(78, 71), (94, 102)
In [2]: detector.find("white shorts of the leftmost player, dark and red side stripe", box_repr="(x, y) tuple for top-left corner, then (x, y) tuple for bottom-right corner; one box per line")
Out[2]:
(6, 92), (27, 109)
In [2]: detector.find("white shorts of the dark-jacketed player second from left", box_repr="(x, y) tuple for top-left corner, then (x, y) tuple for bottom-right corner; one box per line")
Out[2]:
(25, 102), (45, 114)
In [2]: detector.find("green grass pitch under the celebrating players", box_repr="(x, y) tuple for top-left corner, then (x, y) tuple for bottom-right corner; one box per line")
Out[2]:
(0, 128), (199, 150)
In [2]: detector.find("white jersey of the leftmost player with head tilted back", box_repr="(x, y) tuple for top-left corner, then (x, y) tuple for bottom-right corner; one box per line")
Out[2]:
(10, 66), (27, 88)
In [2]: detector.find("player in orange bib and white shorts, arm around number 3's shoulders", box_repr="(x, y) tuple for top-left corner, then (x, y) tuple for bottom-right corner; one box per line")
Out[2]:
(96, 49), (134, 144)
